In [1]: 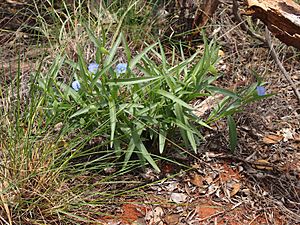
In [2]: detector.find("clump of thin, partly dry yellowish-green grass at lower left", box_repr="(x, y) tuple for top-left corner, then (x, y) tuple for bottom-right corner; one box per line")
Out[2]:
(0, 57), (154, 224)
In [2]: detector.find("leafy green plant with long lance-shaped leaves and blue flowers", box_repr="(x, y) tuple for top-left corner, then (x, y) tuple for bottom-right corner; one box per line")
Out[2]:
(39, 24), (268, 171)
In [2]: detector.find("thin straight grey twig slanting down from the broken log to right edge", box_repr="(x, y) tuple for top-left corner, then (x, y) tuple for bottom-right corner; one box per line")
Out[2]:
(266, 27), (300, 103)
